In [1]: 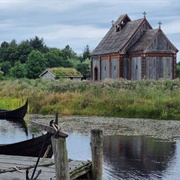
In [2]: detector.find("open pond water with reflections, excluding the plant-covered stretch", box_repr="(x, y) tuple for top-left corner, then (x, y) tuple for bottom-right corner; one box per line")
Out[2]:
(0, 120), (180, 180)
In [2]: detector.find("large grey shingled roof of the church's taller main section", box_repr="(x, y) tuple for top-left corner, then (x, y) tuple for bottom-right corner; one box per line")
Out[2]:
(91, 14), (152, 55)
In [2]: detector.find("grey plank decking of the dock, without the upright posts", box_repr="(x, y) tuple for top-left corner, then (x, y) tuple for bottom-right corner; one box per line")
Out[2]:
(0, 155), (92, 180)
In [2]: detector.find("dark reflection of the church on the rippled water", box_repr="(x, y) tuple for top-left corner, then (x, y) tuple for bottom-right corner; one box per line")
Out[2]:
(103, 136), (176, 179)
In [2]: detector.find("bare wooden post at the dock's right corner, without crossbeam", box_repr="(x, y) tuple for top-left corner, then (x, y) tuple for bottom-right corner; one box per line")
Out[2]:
(91, 129), (103, 180)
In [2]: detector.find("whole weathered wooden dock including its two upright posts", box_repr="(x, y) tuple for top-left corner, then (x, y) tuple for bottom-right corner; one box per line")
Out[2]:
(0, 117), (103, 180)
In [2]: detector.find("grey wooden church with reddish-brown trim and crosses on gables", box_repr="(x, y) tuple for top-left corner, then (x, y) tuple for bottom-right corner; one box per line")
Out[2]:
(90, 12), (178, 81)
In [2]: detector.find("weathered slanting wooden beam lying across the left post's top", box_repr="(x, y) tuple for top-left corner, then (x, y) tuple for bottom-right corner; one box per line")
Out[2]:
(30, 121), (68, 138)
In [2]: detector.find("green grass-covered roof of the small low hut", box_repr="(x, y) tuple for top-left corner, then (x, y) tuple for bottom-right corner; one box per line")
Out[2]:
(49, 67), (82, 77)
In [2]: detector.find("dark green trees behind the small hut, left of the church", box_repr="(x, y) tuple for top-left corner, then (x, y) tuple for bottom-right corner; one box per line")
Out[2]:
(0, 36), (90, 79)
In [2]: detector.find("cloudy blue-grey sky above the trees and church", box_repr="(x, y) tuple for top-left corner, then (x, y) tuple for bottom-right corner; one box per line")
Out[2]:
(0, 0), (180, 61)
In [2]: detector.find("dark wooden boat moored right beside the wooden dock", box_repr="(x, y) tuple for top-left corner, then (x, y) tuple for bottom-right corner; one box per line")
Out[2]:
(0, 132), (53, 158)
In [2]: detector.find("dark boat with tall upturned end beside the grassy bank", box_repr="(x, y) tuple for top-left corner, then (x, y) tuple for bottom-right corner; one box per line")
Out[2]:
(0, 99), (28, 120)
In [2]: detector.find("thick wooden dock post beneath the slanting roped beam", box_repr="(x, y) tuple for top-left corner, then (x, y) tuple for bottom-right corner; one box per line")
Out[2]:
(51, 137), (69, 180)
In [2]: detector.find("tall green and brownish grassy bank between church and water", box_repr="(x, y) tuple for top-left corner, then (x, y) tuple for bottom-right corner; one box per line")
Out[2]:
(0, 79), (180, 120)
